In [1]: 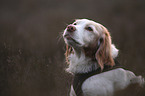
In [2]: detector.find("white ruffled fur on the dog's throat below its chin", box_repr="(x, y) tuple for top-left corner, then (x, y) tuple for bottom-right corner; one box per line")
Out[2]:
(67, 49), (98, 74)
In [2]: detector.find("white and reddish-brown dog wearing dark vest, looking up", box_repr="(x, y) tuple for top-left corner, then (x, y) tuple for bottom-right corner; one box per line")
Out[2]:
(63, 19), (144, 96)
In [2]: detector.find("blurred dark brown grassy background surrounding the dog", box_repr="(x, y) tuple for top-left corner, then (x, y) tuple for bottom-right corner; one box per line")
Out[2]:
(0, 0), (145, 96)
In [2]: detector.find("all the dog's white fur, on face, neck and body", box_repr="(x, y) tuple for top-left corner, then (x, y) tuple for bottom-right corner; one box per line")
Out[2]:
(63, 19), (144, 96)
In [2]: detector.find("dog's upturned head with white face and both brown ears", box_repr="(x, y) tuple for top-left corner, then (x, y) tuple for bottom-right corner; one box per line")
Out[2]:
(63, 19), (118, 69)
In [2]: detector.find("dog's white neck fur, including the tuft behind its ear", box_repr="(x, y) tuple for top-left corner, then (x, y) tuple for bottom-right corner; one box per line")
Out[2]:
(67, 44), (118, 74)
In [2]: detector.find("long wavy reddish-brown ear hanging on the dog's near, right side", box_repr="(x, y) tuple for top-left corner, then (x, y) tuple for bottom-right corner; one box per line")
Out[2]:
(96, 26), (114, 70)
